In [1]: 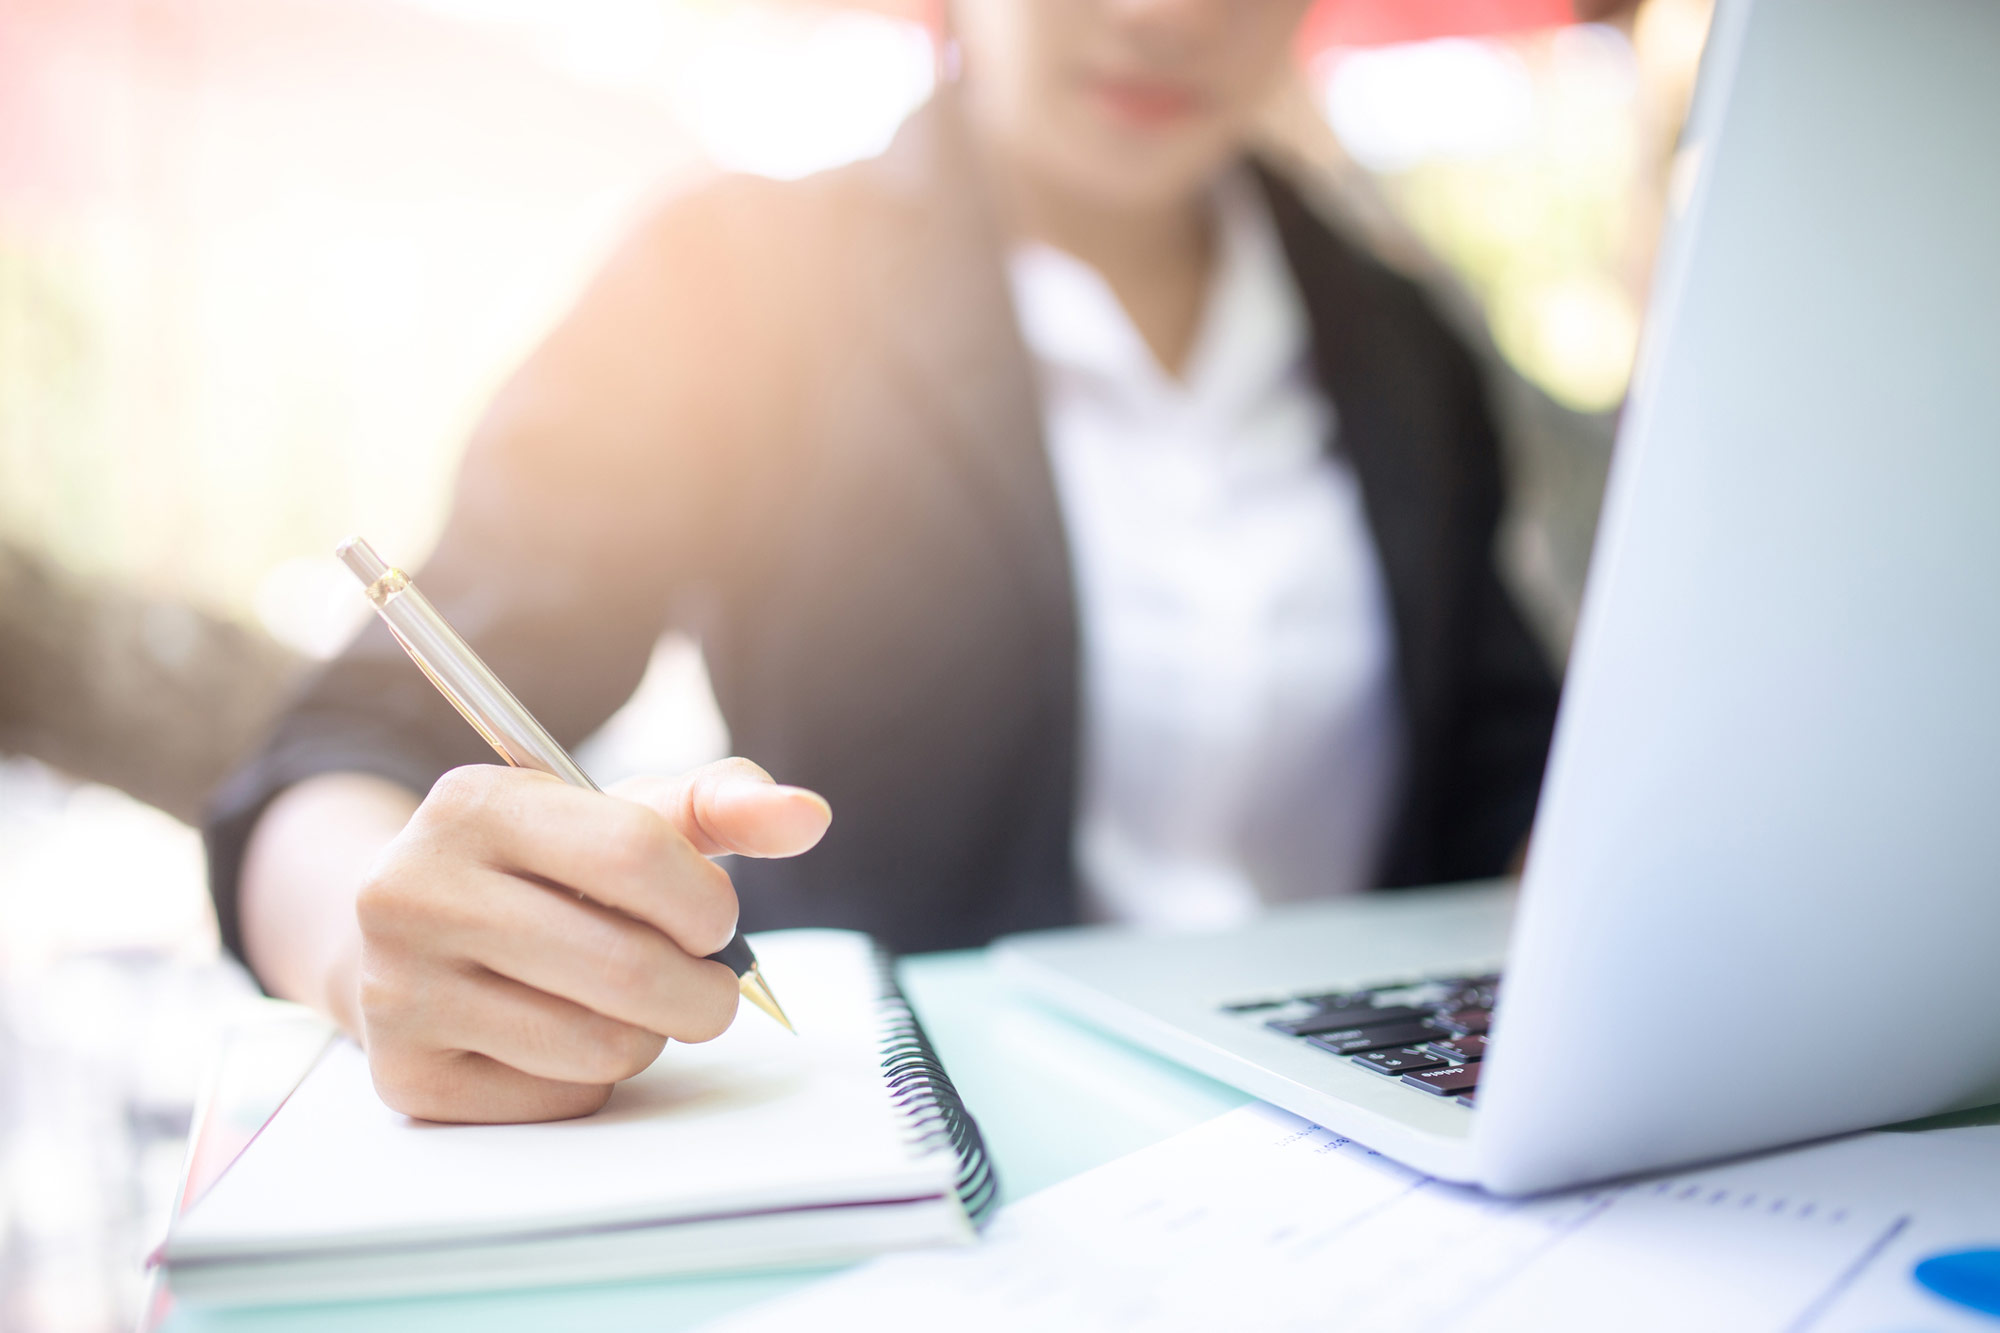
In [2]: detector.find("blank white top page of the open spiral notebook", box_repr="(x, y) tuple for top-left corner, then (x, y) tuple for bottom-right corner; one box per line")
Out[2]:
(168, 931), (958, 1259)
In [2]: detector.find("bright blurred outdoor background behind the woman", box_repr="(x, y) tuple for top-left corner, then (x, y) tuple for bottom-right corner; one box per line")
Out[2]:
(0, 0), (1708, 1329)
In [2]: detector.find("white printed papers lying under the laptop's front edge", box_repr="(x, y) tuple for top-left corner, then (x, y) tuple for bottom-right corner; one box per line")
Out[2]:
(714, 1105), (2000, 1333)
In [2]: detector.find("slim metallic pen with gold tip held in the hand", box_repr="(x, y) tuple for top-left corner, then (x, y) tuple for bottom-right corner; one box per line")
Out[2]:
(334, 536), (798, 1033)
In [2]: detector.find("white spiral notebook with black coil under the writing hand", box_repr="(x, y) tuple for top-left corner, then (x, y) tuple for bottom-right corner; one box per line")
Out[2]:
(160, 931), (996, 1303)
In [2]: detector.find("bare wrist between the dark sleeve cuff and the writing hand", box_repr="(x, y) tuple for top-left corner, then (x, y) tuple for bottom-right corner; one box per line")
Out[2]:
(240, 773), (420, 1037)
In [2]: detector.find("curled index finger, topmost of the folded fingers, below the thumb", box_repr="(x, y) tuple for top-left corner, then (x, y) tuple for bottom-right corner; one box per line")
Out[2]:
(418, 765), (736, 957)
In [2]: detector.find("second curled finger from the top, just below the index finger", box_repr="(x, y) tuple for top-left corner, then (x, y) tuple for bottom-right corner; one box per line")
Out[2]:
(454, 881), (738, 1043)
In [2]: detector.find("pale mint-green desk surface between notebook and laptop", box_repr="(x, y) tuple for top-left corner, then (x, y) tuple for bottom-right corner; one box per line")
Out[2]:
(164, 953), (1250, 1333)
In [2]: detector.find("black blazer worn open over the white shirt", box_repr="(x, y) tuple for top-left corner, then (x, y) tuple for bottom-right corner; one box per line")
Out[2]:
(208, 98), (1556, 953)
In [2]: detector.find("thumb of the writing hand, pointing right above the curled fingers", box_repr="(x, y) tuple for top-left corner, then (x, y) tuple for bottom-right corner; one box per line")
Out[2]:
(612, 759), (834, 857)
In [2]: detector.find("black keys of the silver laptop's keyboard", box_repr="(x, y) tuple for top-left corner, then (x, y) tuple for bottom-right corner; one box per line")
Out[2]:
(1222, 973), (1500, 1107)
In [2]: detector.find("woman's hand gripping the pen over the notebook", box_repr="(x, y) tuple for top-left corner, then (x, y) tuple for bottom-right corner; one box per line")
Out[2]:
(246, 759), (830, 1121)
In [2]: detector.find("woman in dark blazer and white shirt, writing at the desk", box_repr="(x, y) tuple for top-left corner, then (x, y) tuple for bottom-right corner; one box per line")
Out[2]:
(210, 0), (1554, 1121)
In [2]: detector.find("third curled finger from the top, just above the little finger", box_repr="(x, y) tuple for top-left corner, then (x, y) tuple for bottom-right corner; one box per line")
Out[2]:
(424, 965), (672, 1085)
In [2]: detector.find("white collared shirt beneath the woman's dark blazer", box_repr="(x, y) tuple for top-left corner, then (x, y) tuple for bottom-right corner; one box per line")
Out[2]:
(1008, 176), (1402, 929)
